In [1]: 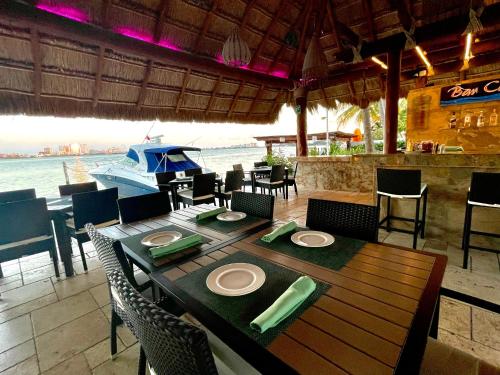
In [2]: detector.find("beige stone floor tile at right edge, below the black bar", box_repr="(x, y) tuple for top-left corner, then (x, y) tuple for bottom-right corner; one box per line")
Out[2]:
(472, 308), (500, 353)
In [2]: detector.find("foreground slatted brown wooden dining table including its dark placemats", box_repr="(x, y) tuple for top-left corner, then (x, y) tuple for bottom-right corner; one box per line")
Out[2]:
(151, 222), (447, 375)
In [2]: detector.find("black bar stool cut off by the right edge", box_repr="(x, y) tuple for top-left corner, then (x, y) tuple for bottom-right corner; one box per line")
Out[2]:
(462, 172), (500, 269)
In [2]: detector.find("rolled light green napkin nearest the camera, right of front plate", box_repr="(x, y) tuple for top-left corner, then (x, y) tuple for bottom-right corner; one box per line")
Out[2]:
(250, 276), (316, 333)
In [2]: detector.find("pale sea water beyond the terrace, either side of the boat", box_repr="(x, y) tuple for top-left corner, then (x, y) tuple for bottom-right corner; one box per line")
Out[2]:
(0, 146), (295, 197)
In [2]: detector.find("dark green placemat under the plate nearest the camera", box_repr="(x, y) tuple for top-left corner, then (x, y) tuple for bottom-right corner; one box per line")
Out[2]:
(175, 251), (330, 347)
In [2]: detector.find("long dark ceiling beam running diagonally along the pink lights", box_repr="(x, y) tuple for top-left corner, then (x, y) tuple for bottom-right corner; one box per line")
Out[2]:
(0, 1), (293, 89)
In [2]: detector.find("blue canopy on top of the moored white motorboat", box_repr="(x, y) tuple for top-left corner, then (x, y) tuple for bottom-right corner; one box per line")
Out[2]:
(127, 144), (201, 173)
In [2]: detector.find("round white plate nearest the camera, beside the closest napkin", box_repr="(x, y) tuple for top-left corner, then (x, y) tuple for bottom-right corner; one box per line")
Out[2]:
(206, 263), (266, 297)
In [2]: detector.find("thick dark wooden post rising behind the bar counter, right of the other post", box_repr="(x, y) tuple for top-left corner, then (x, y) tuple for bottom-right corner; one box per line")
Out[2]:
(384, 49), (402, 154)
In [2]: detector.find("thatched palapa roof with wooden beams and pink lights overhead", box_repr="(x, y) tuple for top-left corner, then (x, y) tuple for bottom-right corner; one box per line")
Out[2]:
(0, 0), (500, 123)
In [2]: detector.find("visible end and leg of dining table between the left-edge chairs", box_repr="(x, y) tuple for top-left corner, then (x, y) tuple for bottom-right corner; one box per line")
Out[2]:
(47, 196), (74, 277)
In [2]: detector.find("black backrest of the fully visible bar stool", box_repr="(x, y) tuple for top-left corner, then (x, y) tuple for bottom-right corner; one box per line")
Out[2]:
(377, 168), (421, 195)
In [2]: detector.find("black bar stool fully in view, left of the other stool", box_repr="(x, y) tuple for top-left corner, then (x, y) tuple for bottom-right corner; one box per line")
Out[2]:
(377, 168), (429, 249)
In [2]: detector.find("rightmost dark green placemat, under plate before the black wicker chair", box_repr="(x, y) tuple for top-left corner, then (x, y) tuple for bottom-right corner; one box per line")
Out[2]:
(254, 228), (366, 271)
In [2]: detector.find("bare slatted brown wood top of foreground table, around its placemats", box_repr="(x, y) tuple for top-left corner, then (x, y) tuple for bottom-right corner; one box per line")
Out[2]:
(151, 223), (446, 375)
